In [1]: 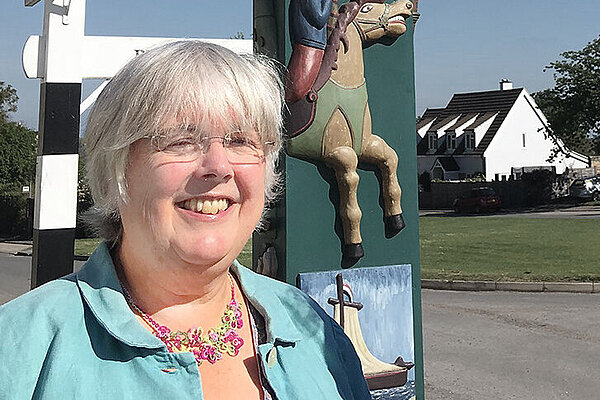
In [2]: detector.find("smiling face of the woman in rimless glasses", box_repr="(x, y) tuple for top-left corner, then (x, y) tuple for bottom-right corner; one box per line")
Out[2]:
(120, 130), (265, 267)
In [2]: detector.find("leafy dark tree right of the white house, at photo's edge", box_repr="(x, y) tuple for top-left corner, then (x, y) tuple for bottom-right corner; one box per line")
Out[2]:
(533, 36), (600, 154)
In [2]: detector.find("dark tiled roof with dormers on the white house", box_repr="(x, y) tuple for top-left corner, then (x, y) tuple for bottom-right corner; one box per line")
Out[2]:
(417, 88), (523, 155)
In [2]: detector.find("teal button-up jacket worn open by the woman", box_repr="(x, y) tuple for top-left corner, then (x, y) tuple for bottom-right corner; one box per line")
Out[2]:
(0, 244), (371, 400)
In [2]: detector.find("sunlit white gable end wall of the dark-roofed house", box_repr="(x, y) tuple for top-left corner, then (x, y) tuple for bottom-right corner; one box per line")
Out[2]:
(485, 90), (585, 180)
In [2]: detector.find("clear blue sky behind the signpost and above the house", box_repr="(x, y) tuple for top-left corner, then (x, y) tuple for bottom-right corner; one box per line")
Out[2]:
(0, 0), (600, 129)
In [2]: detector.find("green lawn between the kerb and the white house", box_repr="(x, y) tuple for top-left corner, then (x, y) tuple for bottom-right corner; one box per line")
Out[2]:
(420, 217), (600, 282)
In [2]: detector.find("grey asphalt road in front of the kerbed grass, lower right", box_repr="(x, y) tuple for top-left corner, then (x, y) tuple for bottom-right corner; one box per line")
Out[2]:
(422, 290), (600, 400)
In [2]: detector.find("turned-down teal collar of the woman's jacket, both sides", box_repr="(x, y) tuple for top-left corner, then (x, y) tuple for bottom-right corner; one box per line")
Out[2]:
(76, 242), (302, 349)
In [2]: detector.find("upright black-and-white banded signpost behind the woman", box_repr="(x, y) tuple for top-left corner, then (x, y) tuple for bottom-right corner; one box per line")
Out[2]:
(25, 0), (85, 288)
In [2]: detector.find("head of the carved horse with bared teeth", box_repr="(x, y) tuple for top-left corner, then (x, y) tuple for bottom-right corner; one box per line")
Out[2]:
(354, 0), (413, 47)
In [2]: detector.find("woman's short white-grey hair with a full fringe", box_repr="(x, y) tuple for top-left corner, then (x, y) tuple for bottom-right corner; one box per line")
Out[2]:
(84, 40), (284, 242)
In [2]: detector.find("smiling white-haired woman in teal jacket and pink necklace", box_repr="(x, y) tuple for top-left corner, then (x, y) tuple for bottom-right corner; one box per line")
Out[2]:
(0, 41), (370, 400)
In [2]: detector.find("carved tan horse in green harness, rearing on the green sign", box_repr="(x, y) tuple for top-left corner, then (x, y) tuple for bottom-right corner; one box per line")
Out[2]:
(286, 0), (413, 262)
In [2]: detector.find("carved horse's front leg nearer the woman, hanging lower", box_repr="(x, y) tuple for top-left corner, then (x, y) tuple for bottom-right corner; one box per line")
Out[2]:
(323, 146), (364, 261)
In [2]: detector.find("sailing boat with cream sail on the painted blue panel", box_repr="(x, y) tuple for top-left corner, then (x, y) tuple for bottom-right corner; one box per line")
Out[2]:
(328, 274), (414, 390)
